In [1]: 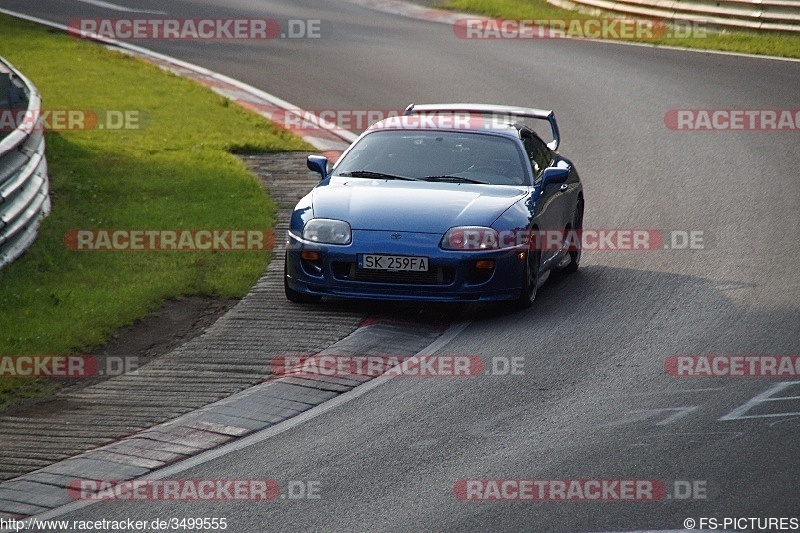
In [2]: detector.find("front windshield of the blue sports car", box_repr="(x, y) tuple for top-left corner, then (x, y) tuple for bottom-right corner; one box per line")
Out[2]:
(334, 130), (527, 185)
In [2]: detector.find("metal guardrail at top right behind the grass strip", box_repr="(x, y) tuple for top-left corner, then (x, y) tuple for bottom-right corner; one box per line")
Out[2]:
(547, 0), (800, 32)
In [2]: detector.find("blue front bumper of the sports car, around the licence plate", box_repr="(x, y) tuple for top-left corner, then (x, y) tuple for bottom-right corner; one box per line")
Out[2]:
(286, 230), (525, 302)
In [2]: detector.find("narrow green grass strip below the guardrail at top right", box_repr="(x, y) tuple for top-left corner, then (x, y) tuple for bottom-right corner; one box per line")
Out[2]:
(437, 0), (800, 58)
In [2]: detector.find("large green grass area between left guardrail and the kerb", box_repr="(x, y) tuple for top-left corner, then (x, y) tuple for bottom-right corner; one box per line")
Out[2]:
(0, 16), (312, 409)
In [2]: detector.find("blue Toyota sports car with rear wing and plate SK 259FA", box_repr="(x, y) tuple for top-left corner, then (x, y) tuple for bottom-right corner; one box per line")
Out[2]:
(284, 104), (584, 307)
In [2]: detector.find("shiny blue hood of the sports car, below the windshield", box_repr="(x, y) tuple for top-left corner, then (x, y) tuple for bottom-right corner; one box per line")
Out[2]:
(312, 178), (528, 233)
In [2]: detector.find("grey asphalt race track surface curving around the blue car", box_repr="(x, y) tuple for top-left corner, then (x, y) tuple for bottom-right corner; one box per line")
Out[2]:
(0, 0), (800, 532)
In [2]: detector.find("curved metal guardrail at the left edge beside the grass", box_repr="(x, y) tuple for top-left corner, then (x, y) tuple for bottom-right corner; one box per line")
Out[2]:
(0, 57), (50, 268)
